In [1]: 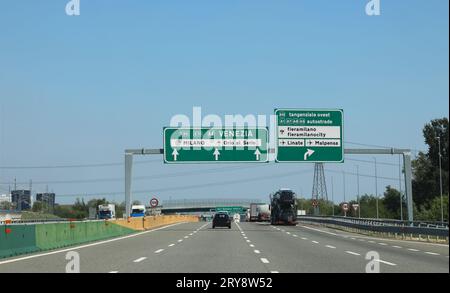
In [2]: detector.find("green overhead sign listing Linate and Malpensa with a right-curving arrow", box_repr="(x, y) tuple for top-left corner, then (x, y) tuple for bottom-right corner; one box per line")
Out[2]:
(275, 109), (344, 163)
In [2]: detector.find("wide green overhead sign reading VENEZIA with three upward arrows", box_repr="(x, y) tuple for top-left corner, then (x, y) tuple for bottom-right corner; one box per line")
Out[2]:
(164, 127), (269, 164)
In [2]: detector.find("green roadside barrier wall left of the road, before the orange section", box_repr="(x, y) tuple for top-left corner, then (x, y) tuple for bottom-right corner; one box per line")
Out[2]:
(0, 221), (135, 258)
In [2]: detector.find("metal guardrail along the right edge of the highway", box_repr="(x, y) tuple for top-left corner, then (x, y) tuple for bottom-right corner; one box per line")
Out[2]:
(297, 216), (449, 237)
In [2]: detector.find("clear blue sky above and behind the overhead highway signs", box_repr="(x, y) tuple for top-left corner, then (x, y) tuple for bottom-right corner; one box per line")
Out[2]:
(0, 0), (449, 202)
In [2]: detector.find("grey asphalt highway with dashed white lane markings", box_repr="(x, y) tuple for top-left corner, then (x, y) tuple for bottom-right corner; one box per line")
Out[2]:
(0, 222), (449, 273)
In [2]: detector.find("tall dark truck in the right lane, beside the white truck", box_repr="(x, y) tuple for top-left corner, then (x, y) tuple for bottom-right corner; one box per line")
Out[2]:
(270, 189), (297, 226)
